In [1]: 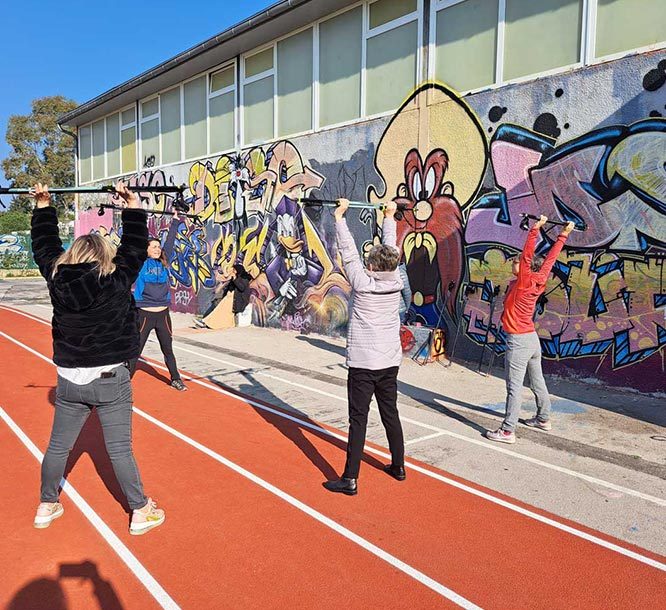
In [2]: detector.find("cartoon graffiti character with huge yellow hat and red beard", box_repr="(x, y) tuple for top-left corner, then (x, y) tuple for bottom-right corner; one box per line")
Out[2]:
(369, 83), (487, 326)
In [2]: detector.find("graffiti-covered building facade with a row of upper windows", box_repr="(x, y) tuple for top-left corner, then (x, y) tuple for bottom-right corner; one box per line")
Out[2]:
(61, 0), (666, 391)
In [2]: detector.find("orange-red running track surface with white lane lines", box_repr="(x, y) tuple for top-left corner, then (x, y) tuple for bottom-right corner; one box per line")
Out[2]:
(0, 307), (666, 610)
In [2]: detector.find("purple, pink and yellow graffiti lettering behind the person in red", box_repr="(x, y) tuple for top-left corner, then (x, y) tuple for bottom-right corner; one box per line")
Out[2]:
(464, 119), (666, 368)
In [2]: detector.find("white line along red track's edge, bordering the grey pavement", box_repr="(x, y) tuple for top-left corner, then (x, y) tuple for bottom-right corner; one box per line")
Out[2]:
(0, 312), (666, 572)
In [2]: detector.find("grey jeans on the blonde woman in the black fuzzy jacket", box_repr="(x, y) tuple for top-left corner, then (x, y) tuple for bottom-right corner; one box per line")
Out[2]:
(41, 366), (148, 509)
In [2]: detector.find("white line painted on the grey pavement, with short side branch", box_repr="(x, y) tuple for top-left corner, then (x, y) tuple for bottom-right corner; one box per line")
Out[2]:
(162, 343), (666, 506)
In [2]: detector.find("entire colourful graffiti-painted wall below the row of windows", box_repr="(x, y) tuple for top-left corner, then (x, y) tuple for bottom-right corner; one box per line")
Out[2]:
(70, 48), (666, 389)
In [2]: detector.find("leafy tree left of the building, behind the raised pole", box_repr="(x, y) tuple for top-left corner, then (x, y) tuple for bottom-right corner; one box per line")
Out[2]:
(2, 95), (77, 214)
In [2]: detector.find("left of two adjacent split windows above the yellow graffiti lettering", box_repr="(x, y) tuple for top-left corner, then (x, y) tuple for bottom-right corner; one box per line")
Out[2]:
(208, 65), (236, 154)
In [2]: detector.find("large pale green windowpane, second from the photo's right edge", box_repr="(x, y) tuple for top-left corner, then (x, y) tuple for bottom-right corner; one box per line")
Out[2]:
(504, 0), (583, 80)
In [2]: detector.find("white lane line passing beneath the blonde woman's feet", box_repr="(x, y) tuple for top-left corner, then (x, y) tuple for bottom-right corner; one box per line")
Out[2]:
(0, 404), (180, 610)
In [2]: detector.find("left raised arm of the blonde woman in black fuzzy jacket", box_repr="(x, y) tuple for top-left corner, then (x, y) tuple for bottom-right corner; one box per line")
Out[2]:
(30, 183), (65, 279)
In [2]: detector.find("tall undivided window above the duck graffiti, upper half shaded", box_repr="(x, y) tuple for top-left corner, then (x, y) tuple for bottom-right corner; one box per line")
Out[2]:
(277, 29), (313, 136)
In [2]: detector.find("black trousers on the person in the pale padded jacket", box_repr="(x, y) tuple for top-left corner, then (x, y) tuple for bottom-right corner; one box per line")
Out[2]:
(342, 366), (405, 479)
